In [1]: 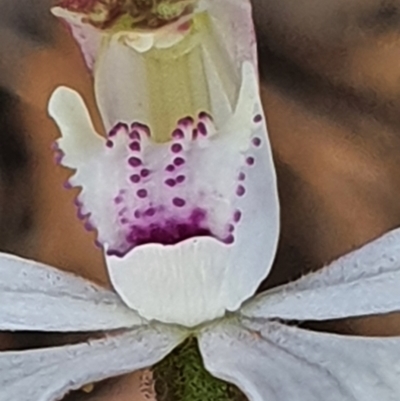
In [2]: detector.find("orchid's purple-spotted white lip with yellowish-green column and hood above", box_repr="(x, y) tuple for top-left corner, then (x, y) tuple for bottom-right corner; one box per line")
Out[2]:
(49, 0), (279, 327)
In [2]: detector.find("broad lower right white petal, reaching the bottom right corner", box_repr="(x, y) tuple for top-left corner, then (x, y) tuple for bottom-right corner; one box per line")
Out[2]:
(200, 321), (400, 401)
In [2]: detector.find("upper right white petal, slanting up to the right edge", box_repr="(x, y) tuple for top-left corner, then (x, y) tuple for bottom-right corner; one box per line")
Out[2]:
(241, 230), (400, 320)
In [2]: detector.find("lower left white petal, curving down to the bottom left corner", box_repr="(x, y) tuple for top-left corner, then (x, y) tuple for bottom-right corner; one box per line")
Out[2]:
(0, 326), (185, 401)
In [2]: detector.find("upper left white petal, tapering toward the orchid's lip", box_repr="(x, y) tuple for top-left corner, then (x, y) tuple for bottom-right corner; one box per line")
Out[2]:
(0, 250), (142, 332)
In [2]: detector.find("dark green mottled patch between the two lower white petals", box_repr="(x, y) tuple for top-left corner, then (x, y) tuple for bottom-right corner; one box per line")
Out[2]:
(153, 338), (246, 401)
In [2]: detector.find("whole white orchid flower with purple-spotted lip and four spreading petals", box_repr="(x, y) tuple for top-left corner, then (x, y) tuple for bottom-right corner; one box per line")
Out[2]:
(0, 0), (400, 401)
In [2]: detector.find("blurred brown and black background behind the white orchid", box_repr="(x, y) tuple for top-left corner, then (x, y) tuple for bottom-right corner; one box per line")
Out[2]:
(0, 0), (400, 400)
